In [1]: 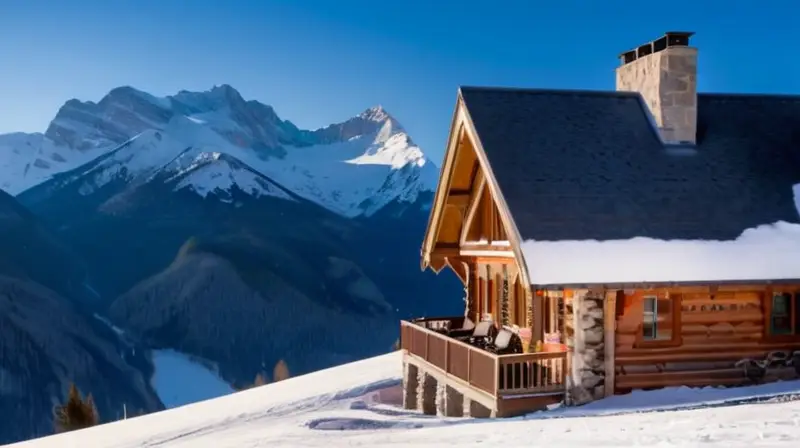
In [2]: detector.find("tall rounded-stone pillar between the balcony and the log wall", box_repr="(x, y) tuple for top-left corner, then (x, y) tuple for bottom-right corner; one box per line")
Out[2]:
(567, 290), (605, 405)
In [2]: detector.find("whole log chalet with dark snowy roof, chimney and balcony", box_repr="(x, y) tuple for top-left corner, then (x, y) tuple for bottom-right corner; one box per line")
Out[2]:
(401, 32), (800, 417)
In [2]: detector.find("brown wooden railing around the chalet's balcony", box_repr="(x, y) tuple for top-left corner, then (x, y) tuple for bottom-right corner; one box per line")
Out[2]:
(400, 318), (567, 398)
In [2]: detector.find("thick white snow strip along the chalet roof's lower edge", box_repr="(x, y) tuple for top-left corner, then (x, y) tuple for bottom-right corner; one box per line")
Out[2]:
(521, 221), (800, 285)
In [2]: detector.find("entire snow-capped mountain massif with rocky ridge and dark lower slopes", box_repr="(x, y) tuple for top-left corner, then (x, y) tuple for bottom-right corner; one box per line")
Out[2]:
(10, 86), (462, 396)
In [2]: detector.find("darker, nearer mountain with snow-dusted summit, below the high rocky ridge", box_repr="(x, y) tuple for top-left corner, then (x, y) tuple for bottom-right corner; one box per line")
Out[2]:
(22, 146), (406, 385)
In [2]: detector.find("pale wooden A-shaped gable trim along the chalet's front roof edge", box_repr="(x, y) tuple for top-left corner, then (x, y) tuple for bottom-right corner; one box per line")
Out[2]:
(420, 90), (530, 284)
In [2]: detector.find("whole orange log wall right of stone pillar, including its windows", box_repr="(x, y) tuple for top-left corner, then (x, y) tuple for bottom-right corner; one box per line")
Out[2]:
(613, 285), (800, 393)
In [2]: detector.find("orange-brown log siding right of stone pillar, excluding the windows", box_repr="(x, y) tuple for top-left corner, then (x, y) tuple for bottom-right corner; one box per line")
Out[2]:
(614, 286), (800, 393)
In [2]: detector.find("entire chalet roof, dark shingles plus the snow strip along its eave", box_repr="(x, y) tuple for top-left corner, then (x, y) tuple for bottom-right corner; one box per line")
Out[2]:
(460, 87), (800, 285)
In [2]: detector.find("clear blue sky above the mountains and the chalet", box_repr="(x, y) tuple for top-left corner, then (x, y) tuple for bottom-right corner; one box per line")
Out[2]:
(0, 0), (800, 163)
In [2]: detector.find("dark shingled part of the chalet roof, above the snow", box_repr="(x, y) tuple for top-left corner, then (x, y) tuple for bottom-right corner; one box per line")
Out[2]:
(461, 87), (800, 241)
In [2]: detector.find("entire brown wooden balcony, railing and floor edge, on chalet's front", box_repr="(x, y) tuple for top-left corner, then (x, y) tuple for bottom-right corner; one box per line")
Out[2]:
(400, 318), (567, 417)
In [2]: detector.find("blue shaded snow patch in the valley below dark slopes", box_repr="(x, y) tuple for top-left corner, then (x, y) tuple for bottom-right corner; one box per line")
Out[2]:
(150, 350), (234, 408)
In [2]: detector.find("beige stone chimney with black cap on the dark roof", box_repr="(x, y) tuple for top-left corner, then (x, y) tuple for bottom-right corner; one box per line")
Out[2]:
(616, 31), (697, 144)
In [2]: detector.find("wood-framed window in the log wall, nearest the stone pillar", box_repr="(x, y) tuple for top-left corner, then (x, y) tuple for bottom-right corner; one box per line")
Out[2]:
(639, 294), (680, 345)
